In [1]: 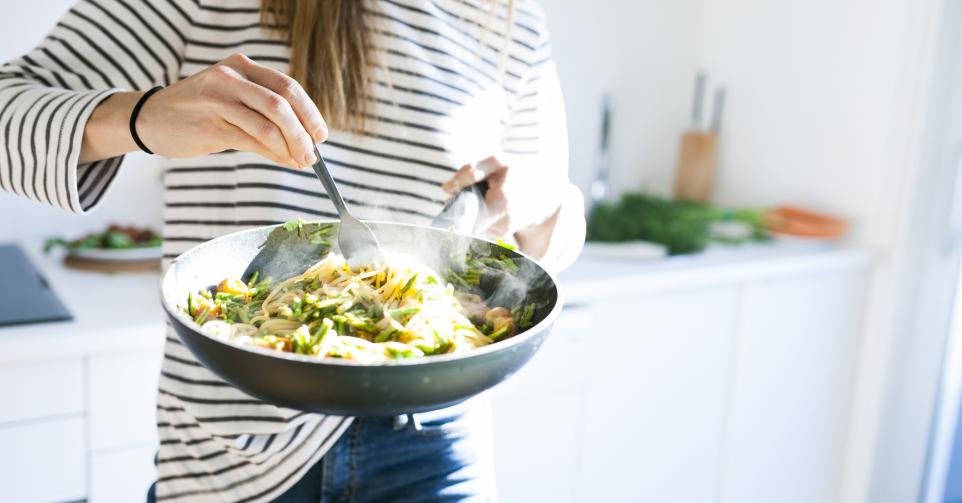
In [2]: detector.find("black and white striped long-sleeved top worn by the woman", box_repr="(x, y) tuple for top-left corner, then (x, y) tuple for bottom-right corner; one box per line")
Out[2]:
(0, 0), (568, 502)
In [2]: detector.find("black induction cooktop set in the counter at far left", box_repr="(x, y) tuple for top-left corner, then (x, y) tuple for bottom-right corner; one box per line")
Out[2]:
(0, 244), (73, 327)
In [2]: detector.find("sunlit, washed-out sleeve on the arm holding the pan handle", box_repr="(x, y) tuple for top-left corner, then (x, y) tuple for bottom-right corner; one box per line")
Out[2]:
(501, 4), (585, 271)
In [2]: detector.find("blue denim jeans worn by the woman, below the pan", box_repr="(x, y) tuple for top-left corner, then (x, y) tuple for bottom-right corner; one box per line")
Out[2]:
(275, 399), (497, 503)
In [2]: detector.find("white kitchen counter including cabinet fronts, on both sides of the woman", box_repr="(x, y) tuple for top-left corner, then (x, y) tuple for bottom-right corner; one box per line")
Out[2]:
(0, 237), (870, 502)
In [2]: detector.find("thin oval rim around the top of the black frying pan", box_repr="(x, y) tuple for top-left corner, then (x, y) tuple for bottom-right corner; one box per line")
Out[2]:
(159, 219), (564, 369)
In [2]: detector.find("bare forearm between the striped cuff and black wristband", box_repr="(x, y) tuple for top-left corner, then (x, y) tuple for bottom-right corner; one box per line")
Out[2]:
(78, 92), (143, 164)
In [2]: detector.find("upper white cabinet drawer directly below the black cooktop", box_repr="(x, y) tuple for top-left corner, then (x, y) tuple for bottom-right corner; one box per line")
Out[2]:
(0, 358), (84, 424)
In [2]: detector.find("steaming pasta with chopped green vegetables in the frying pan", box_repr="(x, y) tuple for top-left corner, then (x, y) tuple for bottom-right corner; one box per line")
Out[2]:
(185, 253), (535, 363)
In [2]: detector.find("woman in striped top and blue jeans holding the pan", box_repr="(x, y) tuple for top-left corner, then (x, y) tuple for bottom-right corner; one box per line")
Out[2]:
(0, 0), (584, 502)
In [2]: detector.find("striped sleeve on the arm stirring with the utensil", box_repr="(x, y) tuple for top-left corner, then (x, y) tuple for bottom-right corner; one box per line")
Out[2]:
(0, 0), (192, 213)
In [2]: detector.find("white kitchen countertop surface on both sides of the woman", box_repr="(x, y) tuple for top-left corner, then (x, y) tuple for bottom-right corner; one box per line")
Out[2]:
(0, 238), (869, 364)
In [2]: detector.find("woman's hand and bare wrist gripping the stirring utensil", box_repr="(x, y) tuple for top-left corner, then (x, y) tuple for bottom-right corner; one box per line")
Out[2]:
(80, 54), (328, 167)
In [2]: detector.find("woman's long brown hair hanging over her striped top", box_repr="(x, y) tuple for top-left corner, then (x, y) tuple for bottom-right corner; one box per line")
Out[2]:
(261, 0), (514, 131)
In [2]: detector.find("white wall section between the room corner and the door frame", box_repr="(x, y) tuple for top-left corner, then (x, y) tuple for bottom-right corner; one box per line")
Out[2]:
(699, 0), (928, 244)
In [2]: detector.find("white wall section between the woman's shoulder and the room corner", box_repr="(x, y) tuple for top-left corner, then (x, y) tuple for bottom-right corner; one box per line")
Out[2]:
(541, 0), (706, 197)
